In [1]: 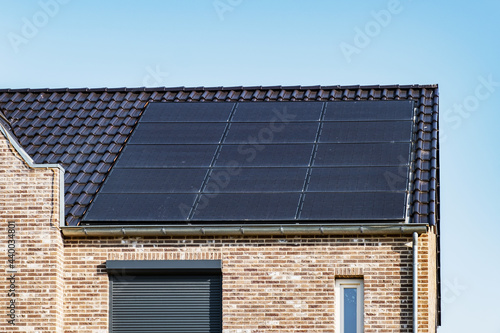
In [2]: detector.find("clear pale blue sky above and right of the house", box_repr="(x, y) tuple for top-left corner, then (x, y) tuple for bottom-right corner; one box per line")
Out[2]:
(0, 0), (500, 333)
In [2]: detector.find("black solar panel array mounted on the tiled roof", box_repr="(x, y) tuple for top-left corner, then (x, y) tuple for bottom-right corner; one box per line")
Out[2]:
(83, 101), (413, 224)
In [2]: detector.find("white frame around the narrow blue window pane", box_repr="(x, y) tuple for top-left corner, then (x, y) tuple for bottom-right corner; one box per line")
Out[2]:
(335, 278), (364, 333)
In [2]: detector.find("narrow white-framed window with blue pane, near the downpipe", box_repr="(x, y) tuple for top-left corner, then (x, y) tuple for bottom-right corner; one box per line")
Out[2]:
(335, 279), (364, 333)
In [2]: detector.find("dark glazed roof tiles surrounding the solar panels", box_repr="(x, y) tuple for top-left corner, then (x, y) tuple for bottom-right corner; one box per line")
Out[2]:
(0, 85), (439, 225)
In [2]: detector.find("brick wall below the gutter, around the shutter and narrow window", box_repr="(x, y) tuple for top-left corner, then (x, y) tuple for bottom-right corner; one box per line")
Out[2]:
(64, 235), (435, 333)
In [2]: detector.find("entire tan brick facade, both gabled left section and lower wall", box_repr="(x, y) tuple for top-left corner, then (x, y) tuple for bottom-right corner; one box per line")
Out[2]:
(0, 122), (436, 333)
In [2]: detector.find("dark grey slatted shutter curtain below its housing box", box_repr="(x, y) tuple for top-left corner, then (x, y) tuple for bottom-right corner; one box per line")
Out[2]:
(110, 260), (222, 333)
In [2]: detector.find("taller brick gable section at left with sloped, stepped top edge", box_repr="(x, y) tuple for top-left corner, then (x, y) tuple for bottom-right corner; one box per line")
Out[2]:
(0, 128), (64, 332)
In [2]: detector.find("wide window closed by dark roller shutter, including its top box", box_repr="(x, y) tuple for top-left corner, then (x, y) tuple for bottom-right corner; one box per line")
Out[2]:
(106, 260), (222, 333)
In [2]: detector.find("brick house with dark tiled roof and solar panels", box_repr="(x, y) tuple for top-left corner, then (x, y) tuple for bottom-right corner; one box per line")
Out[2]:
(0, 85), (440, 333)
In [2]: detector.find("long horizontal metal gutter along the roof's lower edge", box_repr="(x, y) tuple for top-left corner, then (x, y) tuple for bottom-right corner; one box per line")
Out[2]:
(61, 223), (428, 237)
